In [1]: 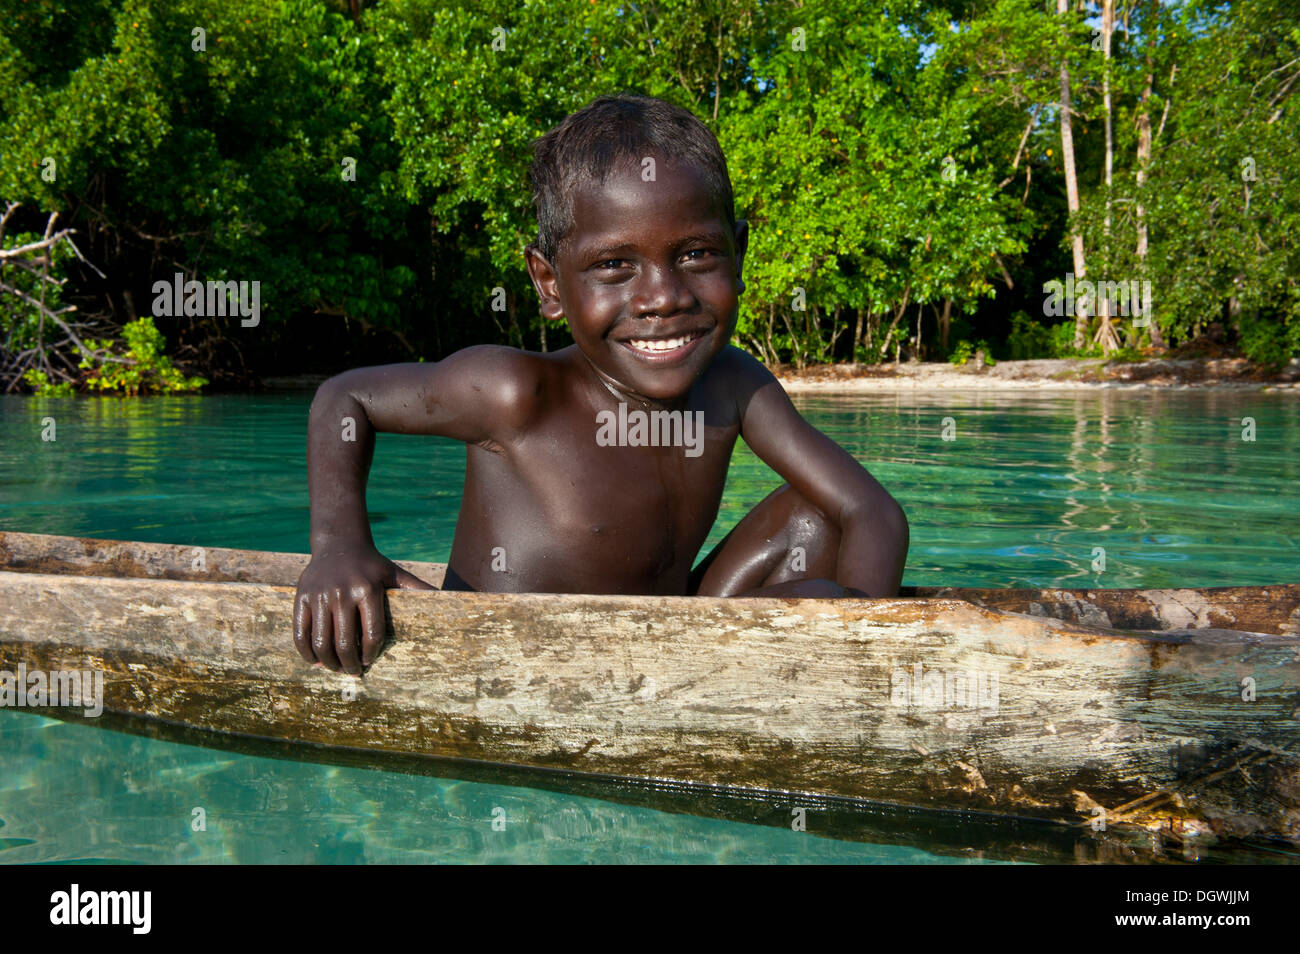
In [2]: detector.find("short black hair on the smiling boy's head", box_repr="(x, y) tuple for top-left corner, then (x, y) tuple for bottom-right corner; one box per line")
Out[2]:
(529, 92), (736, 265)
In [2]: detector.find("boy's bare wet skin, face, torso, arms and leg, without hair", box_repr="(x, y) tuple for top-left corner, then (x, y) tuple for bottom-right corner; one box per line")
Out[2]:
(294, 159), (907, 673)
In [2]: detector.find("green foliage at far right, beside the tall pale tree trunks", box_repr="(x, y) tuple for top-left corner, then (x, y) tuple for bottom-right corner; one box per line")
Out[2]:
(1055, 0), (1300, 364)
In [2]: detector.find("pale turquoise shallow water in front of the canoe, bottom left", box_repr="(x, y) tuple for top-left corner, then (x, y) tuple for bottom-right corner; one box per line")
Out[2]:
(0, 710), (993, 864)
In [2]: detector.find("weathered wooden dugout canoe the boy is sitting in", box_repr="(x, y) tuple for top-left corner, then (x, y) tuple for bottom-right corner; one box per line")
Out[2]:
(0, 533), (1300, 850)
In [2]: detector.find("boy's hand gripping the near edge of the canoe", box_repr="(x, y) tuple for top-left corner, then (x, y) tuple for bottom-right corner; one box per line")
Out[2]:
(294, 547), (437, 676)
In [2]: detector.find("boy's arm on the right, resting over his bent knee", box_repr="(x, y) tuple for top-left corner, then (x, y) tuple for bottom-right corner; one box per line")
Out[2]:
(732, 350), (909, 597)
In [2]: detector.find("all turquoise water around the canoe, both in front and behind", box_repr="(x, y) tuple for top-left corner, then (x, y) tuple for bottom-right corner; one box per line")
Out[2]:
(0, 393), (1300, 863)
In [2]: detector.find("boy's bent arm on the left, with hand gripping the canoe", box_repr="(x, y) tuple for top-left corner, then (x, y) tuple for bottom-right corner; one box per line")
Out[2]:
(294, 346), (538, 675)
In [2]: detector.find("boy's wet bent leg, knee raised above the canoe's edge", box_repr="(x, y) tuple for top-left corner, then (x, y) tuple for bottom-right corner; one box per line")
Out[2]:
(689, 483), (846, 597)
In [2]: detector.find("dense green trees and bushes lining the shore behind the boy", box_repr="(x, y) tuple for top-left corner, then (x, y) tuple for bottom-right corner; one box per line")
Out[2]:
(0, 0), (1300, 393)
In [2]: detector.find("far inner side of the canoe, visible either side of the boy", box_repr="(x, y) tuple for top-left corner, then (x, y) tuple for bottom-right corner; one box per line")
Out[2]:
(0, 532), (1300, 636)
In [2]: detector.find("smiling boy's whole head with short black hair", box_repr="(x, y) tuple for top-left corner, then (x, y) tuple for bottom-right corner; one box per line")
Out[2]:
(525, 95), (749, 400)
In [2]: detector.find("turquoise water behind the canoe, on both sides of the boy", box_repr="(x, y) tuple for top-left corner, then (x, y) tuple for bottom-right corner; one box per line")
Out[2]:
(0, 391), (1300, 587)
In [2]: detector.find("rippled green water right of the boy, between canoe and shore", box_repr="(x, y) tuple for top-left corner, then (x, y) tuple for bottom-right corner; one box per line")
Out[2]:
(750, 391), (1300, 587)
